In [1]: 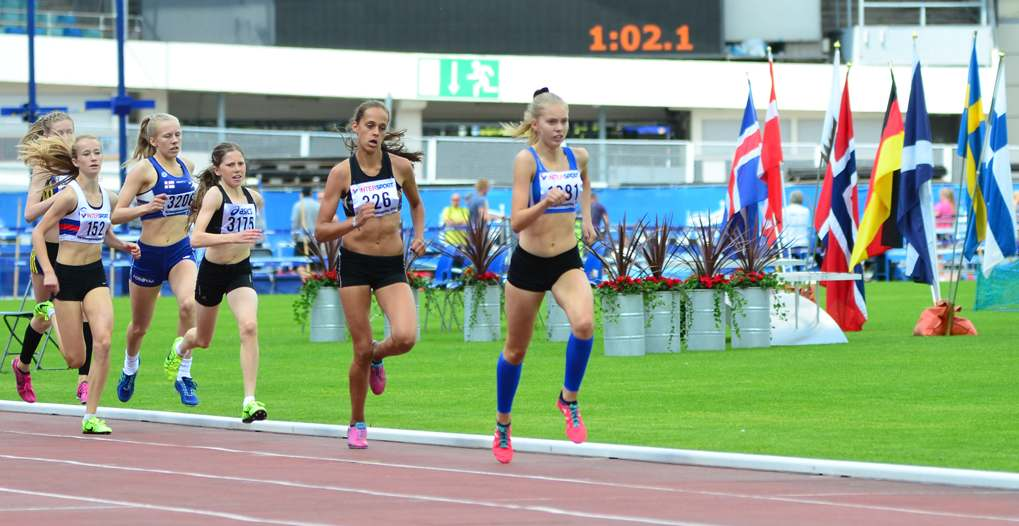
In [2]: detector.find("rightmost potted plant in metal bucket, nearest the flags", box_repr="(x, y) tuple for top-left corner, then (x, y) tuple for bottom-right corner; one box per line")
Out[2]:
(729, 224), (786, 348)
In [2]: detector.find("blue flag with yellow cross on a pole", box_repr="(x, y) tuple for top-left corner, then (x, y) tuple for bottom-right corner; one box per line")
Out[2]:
(957, 36), (987, 259)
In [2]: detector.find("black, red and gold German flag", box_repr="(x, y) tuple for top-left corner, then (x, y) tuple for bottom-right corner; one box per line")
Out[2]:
(849, 75), (903, 267)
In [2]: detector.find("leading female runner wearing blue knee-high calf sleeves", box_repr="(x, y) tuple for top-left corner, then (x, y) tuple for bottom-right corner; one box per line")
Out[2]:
(492, 88), (595, 464)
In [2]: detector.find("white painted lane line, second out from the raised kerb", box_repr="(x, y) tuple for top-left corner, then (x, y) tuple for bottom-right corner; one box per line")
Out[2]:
(0, 455), (715, 526)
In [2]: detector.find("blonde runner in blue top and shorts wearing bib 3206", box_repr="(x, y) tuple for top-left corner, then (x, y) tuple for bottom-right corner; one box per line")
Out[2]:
(113, 113), (199, 406)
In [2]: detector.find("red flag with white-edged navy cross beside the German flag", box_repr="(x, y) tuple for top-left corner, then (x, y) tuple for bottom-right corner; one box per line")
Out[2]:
(821, 72), (867, 330)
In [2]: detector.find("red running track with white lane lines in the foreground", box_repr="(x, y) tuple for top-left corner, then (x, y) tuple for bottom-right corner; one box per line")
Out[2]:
(0, 413), (1019, 526)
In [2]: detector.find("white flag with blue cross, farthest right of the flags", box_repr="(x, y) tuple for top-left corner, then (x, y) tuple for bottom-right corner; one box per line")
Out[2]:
(980, 57), (1016, 277)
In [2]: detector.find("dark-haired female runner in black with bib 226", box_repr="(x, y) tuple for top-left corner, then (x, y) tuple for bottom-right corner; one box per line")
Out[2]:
(315, 101), (425, 450)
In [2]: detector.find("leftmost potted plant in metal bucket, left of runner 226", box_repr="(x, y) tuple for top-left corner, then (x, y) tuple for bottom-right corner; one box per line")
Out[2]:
(293, 231), (346, 341)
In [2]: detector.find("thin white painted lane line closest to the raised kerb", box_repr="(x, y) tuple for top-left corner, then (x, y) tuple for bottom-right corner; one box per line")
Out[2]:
(7, 431), (1019, 522)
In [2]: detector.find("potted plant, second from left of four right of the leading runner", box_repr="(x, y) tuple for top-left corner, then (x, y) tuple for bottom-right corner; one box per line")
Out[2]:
(641, 219), (684, 353)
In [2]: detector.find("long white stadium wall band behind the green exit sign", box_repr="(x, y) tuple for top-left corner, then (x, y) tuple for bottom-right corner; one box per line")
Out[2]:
(0, 35), (994, 113)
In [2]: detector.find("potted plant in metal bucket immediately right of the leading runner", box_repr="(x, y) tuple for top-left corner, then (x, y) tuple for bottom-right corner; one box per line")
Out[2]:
(589, 215), (647, 356)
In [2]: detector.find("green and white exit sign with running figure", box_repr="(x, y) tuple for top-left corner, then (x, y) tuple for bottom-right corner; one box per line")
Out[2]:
(418, 58), (499, 100)
